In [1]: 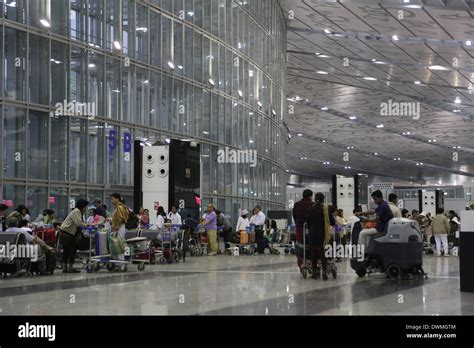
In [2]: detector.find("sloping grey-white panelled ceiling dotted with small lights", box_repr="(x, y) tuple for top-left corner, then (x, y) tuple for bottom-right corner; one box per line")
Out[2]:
(280, 0), (474, 185)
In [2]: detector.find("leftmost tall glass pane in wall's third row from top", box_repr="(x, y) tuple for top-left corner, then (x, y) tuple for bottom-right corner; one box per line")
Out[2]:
(3, 107), (26, 178)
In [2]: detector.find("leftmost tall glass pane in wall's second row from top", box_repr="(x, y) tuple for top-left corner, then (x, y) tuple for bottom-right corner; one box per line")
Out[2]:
(4, 28), (27, 100)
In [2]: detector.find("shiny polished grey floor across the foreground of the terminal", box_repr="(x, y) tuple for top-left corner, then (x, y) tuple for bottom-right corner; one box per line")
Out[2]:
(0, 250), (474, 315)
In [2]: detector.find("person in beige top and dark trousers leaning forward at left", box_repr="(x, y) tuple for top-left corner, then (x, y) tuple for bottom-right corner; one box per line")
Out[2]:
(59, 198), (89, 273)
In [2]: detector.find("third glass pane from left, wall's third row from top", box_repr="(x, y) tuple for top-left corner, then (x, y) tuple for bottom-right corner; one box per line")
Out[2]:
(50, 115), (69, 181)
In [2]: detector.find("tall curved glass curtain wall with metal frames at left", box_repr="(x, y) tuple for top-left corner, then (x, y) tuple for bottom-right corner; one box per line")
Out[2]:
(0, 0), (287, 220)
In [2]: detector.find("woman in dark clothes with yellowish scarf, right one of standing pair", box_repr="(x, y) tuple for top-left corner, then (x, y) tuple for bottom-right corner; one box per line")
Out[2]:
(306, 192), (336, 280)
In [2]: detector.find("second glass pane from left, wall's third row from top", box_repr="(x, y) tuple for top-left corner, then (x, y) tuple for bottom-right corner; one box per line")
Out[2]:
(27, 110), (49, 180)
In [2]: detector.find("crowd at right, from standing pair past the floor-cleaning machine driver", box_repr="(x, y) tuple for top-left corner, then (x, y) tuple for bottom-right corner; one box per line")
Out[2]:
(293, 189), (466, 280)
